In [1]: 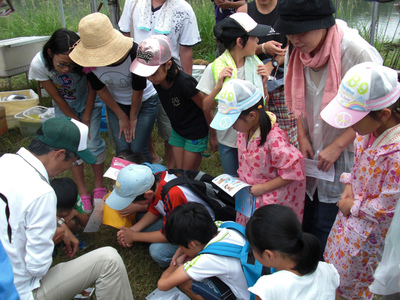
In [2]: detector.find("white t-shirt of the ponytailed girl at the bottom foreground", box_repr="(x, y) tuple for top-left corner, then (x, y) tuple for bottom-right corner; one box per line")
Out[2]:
(249, 262), (340, 300)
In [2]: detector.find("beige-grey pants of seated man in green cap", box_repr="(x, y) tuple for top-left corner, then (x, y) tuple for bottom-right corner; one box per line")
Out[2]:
(32, 247), (133, 300)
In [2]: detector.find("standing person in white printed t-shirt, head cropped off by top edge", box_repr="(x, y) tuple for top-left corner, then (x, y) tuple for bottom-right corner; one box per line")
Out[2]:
(118, 0), (201, 169)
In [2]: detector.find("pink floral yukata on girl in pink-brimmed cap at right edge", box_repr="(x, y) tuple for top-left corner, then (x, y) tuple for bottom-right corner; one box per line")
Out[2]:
(324, 125), (400, 299)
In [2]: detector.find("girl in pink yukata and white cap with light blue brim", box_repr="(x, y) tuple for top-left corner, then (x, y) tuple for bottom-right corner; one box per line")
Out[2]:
(211, 79), (306, 225)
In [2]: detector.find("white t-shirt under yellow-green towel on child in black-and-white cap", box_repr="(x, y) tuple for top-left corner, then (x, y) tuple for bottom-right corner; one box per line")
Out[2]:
(196, 64), (245, 148)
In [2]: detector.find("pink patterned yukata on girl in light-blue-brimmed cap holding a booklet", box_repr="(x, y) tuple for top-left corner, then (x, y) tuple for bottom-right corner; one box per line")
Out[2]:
(236, 113), (306, 226)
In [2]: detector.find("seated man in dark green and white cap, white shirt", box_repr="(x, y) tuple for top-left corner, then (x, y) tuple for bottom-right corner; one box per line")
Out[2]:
(0, 117), (133, 300)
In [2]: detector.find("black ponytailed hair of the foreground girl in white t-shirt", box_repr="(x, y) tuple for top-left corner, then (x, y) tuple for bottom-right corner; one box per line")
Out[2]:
(246, 204), (321, 275)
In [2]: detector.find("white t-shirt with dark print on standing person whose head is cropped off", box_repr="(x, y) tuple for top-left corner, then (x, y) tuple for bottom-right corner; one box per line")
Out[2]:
(118, 0), (201, 65)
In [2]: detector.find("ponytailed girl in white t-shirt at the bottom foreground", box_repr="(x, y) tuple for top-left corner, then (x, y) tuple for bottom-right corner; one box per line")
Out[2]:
(246, 204), (339, 300)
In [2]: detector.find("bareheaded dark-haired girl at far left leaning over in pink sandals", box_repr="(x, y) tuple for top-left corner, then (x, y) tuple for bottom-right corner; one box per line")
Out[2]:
(29, 29), (106, 212)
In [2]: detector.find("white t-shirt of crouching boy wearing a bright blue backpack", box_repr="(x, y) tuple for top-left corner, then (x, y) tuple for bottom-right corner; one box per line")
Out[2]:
(183, 228), (250, 300)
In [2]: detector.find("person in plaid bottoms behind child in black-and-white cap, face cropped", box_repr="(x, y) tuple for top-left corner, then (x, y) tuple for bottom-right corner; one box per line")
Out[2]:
(237, 0), (297, 146)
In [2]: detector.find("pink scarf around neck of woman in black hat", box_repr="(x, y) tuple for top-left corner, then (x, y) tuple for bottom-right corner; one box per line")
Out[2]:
(285, 24), (343, 117)
